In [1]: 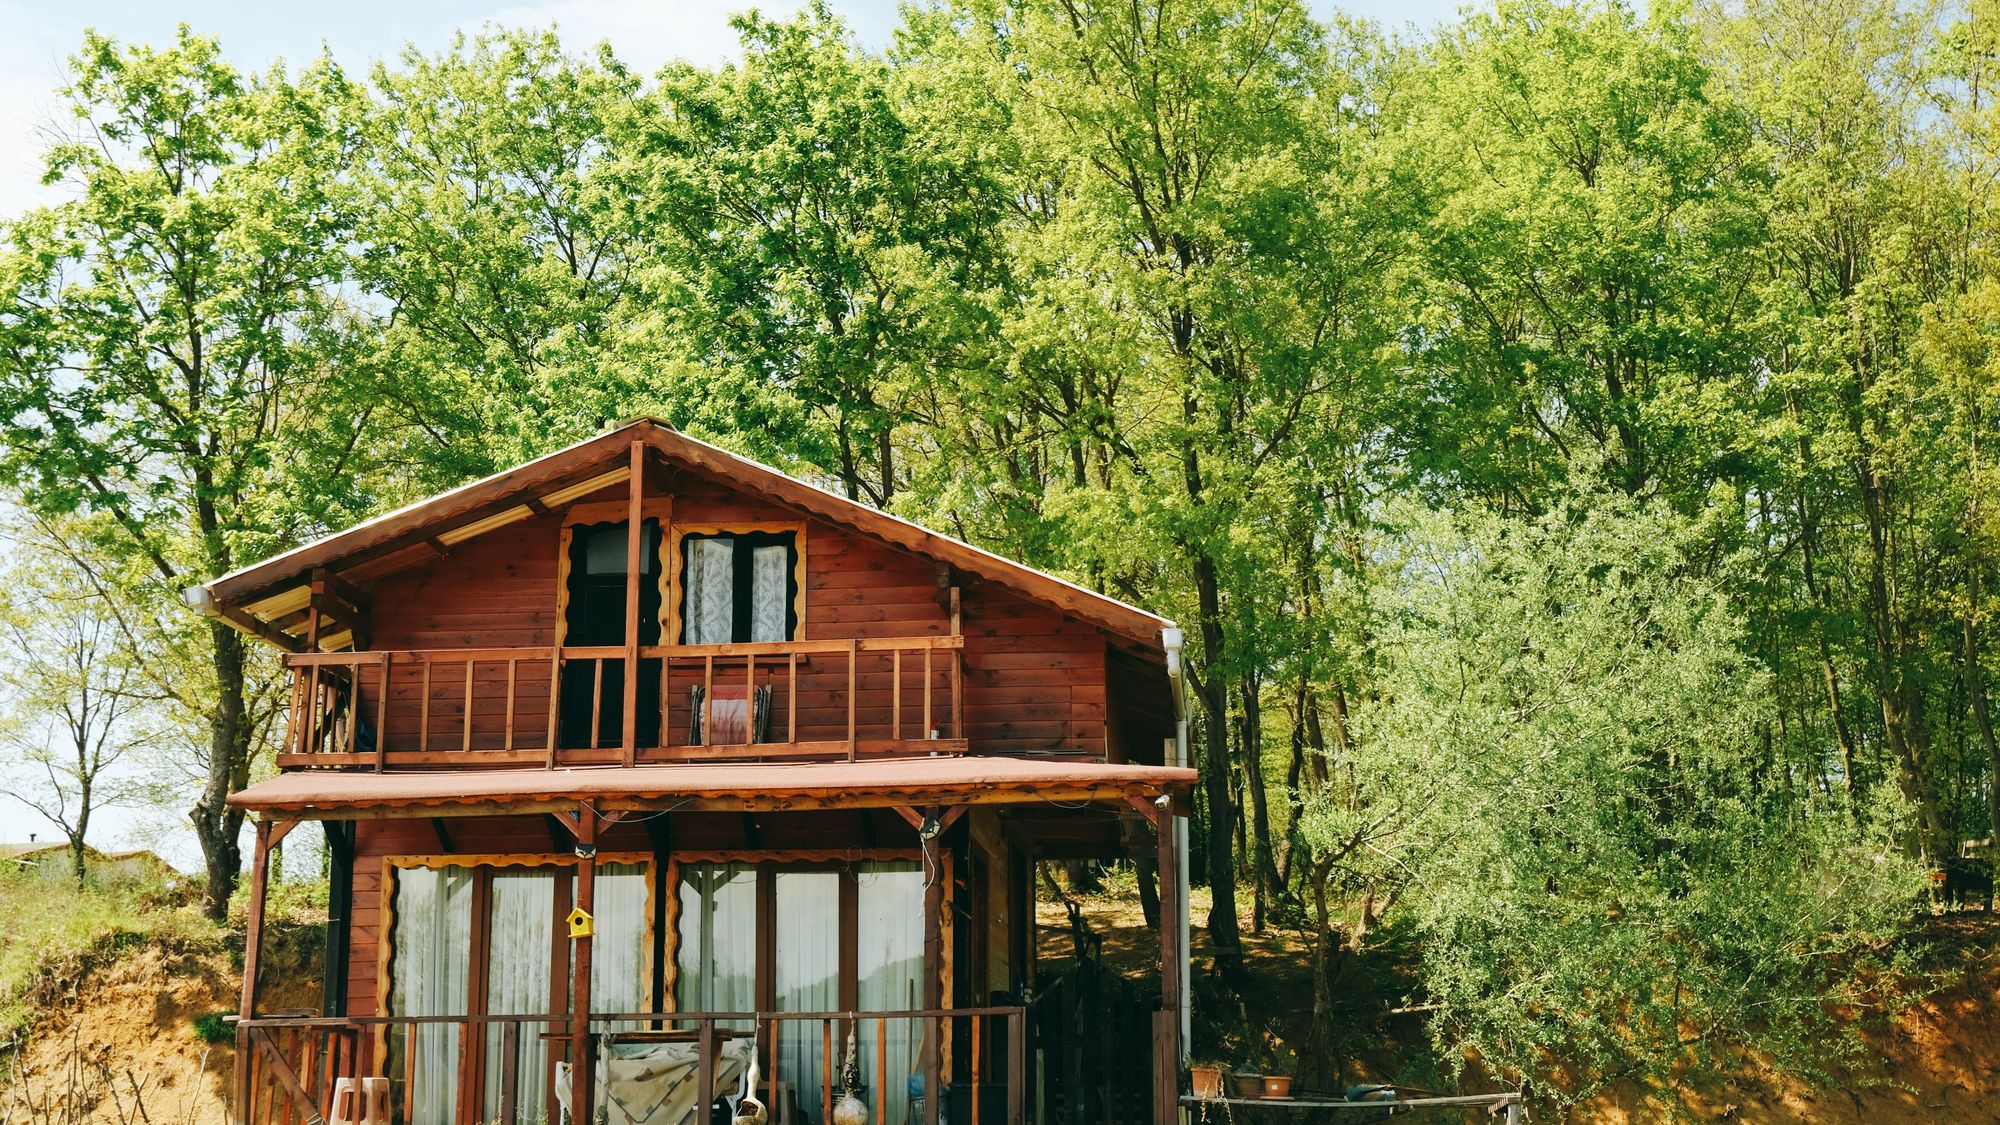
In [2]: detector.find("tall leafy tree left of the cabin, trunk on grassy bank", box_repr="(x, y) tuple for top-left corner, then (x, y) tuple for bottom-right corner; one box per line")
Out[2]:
(0, 28), (364, 919)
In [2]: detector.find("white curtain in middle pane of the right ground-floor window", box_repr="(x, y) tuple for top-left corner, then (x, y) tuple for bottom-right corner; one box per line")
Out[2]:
(772, 871), (840, 1125)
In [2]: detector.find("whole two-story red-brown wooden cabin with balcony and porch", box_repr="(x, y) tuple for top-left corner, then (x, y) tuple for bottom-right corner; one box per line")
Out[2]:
(207, 420), (1194, 1125)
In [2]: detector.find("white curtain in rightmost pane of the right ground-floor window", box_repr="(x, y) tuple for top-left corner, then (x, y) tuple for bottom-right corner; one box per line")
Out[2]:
(854, 863), (924, 1125)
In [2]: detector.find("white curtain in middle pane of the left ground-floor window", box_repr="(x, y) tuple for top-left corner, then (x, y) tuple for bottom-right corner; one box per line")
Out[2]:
(484, 867), (556, 1121)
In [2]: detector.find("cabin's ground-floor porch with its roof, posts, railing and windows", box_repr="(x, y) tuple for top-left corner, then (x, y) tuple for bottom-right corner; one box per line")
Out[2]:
(223, 755), (1192, 1125)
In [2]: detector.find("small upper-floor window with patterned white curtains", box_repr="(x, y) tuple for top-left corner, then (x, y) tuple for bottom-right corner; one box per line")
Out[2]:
(680, 530), (800, 645)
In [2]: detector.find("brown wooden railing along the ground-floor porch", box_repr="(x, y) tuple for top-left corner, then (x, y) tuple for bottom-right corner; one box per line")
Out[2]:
(236, 1007), (1030, 1125)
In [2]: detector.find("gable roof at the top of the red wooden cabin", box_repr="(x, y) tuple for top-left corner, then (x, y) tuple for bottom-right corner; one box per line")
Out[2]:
(186, 418), (1174, 657)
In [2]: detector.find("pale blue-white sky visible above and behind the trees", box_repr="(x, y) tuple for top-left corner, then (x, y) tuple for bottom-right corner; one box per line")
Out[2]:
(0, 0), (1470, 871)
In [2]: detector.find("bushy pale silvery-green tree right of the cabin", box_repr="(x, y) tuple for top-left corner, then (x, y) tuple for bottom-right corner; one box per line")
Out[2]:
(1306, 490), (1922, 1097)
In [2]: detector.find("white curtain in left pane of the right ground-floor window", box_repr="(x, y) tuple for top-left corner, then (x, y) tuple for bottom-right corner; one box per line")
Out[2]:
(674, 863), (756, 1029)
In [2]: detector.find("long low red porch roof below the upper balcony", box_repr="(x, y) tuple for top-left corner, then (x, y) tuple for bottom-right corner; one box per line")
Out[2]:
(230, 757), (1194, 821)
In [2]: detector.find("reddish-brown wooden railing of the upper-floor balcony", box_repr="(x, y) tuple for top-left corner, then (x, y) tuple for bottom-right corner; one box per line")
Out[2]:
(278, 637), (966, 769)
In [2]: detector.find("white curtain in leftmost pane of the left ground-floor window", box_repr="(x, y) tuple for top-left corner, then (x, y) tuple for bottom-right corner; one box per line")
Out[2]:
(388, 867), (472, 1125)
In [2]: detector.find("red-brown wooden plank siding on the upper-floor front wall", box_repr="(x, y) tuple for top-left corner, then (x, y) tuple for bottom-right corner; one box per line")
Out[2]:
(346, 460), (1128, 761)
